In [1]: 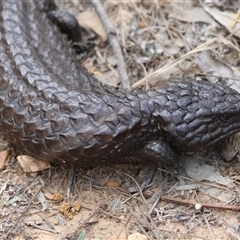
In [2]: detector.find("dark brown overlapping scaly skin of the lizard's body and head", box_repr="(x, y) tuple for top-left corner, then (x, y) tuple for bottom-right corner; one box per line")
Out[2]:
(0, 0), (240, 166)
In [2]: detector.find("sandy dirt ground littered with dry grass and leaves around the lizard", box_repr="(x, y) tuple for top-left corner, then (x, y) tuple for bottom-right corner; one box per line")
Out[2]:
(0, 0), (240, 240)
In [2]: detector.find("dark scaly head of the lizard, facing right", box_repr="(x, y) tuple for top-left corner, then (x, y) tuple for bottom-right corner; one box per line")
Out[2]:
(153, 81), (240, 151)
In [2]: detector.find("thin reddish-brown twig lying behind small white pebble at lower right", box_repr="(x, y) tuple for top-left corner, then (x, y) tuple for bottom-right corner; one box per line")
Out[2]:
(161, 196), (240, 212)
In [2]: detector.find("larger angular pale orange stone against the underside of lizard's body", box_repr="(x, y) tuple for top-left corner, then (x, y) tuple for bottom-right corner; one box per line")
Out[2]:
(17, 155), (51, 173)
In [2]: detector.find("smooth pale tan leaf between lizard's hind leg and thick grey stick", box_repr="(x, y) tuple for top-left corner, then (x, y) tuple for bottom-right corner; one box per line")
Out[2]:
(77, 11), (107, 42)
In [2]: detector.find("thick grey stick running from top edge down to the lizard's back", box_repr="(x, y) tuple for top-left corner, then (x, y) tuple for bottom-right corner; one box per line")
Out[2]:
(91, 0), (131, 90)
